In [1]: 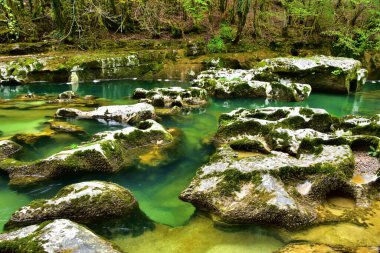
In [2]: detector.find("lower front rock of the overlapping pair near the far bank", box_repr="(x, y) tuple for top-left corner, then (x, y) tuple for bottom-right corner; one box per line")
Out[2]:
(193, 69), (311, 101)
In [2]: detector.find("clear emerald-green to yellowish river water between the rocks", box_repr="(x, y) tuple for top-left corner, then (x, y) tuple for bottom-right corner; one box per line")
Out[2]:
(0, 80), (380, 252)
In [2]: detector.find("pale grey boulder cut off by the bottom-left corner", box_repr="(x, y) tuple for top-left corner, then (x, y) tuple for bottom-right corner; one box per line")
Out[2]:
(0, 219), (121, 253)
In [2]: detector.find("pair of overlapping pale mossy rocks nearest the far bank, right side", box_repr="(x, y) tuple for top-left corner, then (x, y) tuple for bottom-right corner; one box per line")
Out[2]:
(193, 56), (367, 101)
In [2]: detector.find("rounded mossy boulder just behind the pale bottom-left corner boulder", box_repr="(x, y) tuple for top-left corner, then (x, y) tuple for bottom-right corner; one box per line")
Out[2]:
(5, 181), (143, 229)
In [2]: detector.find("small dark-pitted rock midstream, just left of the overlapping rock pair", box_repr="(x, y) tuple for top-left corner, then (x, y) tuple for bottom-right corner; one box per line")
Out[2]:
(132, 87), (208, 108)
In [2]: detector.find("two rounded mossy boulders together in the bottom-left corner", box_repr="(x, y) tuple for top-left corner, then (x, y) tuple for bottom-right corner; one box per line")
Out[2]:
(0, 181), (153, 253)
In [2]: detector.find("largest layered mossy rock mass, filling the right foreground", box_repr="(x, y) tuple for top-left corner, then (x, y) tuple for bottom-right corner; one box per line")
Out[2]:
(180, 107), (380, 228)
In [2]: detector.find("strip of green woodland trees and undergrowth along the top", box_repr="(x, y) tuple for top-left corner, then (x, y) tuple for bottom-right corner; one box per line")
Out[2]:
(0, 0), (380, 57)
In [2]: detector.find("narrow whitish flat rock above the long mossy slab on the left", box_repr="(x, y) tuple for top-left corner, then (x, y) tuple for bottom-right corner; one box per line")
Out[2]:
(56, 103), (156, 124)
